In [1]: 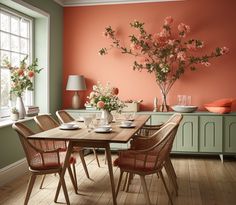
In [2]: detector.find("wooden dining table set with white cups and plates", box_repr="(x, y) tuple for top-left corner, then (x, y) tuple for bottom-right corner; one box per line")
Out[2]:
(28, 115), (150, 205)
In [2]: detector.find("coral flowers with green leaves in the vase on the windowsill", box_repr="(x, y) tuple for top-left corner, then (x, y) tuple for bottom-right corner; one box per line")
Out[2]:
(4, 56), (42, 97)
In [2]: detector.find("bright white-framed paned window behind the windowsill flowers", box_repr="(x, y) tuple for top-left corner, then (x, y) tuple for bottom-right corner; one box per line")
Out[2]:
(0, 6), (32, 117)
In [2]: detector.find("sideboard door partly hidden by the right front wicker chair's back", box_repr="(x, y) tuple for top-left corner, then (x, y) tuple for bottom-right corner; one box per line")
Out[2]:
(176, 116), (198, 152)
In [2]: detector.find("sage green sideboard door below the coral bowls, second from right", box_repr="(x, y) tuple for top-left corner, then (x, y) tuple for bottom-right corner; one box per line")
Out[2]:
(199, 116), (223, 153)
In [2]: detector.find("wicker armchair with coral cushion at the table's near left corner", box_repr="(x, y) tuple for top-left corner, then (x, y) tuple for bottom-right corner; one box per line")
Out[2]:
(12, 122), (77, 205)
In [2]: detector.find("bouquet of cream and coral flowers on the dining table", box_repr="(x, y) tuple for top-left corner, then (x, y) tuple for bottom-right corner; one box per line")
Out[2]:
(87, 82), (125, 112)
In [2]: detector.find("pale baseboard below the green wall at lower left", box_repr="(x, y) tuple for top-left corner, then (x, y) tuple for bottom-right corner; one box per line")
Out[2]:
(0, 158), (28, 187)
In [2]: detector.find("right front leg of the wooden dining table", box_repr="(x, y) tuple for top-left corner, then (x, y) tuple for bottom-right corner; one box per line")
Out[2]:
(106, 144), (117, 205)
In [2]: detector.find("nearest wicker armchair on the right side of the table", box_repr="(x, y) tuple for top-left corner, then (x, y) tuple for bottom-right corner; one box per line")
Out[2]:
(114, 122), (179, 205)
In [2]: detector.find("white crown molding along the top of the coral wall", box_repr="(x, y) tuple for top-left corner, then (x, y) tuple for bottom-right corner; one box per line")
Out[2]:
(54, 0), (184, 7)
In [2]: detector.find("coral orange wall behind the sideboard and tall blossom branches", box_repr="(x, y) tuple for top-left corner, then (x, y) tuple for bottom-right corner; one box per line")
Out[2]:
(63, 0), (236, 110)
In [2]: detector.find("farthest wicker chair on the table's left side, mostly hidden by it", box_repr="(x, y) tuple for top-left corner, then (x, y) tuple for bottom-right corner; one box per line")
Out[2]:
(56, 110), (100, 167)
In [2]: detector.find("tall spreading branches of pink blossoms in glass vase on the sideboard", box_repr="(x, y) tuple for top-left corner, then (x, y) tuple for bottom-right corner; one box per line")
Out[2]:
(99, 16), (229, 111)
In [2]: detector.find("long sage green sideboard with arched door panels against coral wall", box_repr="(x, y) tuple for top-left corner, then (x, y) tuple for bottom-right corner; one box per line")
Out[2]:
(67, 110), (236, 160)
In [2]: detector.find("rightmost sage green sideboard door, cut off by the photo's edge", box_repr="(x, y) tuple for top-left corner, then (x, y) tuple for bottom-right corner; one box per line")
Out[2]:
(224, 116), (236, 153)
